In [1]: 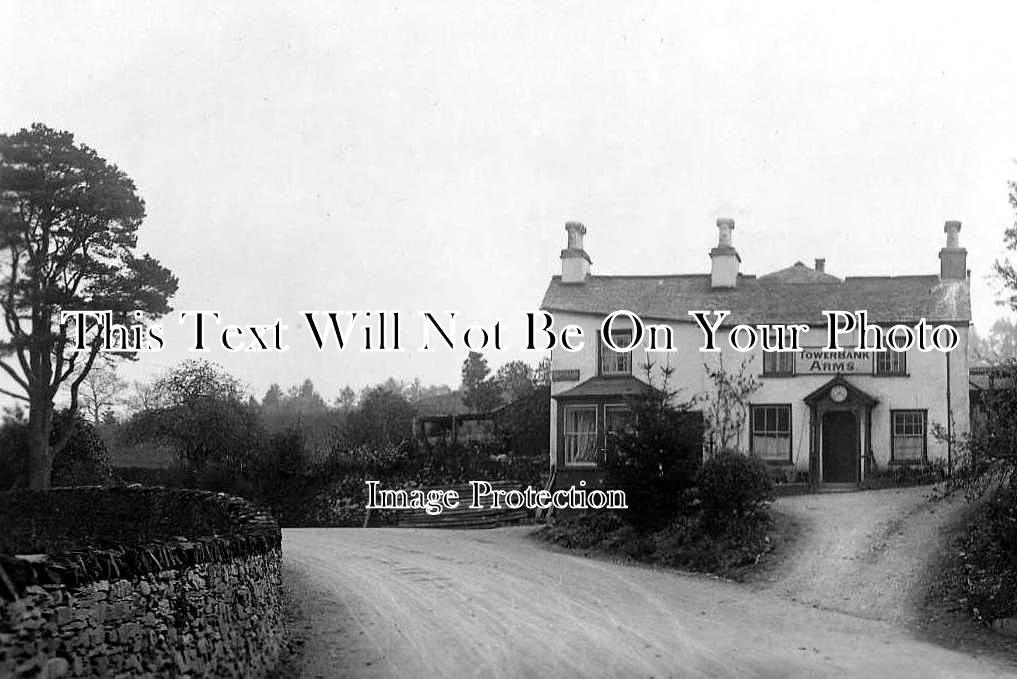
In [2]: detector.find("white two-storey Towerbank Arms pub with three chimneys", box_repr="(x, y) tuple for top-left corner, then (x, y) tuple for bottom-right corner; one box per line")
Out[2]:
(541, 219), (970, 487)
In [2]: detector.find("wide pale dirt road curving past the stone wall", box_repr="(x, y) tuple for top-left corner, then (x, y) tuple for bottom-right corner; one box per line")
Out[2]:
(283, 528), (1017, 677)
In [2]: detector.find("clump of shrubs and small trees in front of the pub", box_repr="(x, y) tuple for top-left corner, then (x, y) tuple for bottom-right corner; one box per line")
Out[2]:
(539, 365), (775, 577)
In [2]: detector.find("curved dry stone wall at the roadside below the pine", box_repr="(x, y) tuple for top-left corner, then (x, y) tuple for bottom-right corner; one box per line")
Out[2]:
(0, 488), (283, 677)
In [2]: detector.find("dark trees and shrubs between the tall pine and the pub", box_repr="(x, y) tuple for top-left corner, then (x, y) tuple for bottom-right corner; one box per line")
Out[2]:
(0, 354), (550, 526)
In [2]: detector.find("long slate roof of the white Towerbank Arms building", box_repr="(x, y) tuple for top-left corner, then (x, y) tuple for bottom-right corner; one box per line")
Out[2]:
(541, 262), (971, 325)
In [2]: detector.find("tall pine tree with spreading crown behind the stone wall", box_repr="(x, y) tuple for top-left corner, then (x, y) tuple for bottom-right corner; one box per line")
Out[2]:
(0, 124), (177, 488)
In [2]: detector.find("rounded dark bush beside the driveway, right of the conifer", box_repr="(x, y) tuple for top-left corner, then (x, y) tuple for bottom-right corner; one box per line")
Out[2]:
(696, 450), (774, 532)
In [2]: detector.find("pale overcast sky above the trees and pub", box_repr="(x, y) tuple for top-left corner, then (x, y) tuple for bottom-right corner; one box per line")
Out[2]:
(0, 0), (1017, 399)
